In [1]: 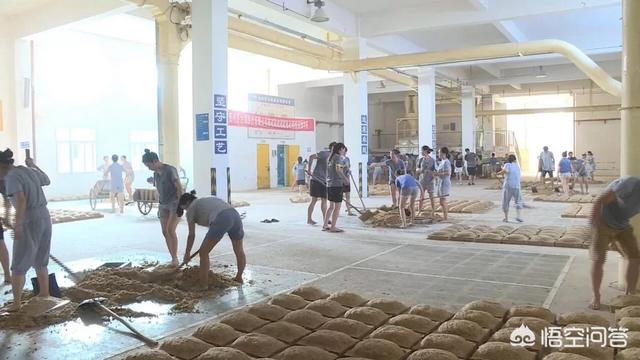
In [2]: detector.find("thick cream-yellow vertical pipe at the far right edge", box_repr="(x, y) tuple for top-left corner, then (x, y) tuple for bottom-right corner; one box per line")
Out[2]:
(620, 0), (640, 177)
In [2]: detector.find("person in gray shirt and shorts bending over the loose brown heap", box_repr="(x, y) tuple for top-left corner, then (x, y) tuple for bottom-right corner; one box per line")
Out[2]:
(176, 191), (247, 290)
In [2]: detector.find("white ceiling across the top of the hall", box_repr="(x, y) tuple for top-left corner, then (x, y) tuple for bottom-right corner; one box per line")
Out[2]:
(0, 0), (624, 87)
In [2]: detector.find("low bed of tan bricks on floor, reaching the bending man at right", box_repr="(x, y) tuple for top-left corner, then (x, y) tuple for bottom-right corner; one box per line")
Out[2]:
(427, 224), (591, 248)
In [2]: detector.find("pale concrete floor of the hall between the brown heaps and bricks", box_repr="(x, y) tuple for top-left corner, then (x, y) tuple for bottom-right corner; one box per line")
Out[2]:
(0, 181), (620, 359)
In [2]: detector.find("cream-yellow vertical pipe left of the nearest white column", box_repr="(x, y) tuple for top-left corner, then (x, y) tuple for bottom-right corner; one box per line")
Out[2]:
(156, 13), (186, 167)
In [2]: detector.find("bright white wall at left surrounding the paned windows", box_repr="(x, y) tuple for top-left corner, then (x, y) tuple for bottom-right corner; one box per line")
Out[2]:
(34, 29), (157, 197)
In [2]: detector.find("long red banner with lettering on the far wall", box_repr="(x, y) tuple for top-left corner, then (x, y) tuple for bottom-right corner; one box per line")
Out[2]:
(228, 110), (315, 131)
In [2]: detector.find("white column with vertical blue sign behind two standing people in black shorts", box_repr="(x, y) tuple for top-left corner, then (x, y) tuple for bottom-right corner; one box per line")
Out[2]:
(343, 39), (369, 196)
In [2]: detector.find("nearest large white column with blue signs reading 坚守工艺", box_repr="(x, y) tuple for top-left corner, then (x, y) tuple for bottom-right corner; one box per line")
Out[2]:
(192, 0), (231, 201)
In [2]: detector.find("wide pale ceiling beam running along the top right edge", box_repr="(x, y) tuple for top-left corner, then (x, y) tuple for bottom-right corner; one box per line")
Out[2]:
(360, 0), (620, 37)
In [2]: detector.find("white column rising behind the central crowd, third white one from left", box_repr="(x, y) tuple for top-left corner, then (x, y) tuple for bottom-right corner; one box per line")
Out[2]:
(418, 67), (436, 149)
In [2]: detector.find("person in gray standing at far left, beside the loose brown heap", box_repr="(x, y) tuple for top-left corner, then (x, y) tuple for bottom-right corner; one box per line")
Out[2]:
(0, 149), (51, 312)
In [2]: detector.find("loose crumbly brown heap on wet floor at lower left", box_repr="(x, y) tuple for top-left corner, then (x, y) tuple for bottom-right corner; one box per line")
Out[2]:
(0, 266), (238, 330)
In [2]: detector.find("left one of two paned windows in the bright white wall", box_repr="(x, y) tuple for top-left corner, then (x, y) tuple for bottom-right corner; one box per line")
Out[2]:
(56, 128), (96, 174)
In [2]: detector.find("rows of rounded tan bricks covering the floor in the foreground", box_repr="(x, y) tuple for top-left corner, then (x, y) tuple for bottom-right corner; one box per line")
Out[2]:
(126, 287), (640, 360)
